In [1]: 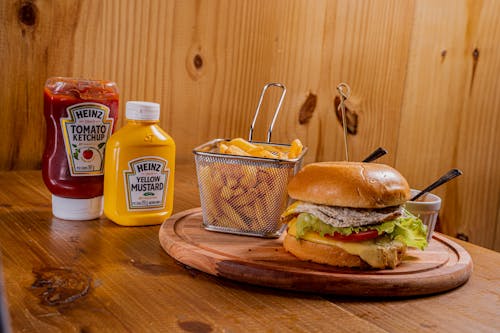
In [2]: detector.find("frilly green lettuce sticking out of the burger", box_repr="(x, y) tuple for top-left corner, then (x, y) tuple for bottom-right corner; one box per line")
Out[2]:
(296, 211), (427, 250)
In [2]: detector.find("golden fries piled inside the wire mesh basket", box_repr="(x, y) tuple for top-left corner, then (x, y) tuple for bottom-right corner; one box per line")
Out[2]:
(198, 138), (303, 233)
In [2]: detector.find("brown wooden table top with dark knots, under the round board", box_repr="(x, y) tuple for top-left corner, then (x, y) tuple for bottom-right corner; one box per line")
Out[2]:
(0, 164), (500, 332)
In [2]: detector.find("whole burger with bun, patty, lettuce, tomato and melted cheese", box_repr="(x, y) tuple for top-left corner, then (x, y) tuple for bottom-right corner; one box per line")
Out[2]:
(281, 162), (427, 269)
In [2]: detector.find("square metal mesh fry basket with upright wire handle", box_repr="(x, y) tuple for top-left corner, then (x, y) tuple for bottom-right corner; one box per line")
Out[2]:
(193, 83), (307, 238)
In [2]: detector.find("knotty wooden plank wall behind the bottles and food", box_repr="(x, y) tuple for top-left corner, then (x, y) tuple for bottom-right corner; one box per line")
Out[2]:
(0, 0), (500, 250)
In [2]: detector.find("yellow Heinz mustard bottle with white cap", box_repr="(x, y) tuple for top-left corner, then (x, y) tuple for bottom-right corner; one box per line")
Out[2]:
(104, 101), (175, 226)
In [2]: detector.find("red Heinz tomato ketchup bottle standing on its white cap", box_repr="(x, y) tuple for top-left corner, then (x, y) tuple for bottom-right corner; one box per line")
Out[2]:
(42, 77), (118, 220)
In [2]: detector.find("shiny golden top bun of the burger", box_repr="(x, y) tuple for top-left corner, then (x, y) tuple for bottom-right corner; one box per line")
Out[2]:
(288, 162), (410, 208)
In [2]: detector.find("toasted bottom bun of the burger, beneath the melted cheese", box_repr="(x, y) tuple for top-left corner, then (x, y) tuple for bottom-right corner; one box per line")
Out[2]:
(283, 234), (406, 269)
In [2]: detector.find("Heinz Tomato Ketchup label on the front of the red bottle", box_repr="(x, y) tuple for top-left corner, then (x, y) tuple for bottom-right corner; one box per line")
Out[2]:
(61, 103), (113, 176)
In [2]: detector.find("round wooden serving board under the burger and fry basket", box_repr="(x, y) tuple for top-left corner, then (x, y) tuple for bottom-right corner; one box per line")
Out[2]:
(159, 208), (472, 297)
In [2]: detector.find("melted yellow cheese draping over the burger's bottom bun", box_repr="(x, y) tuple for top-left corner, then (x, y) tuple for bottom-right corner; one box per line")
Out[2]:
(288, 218), (405, 268)
